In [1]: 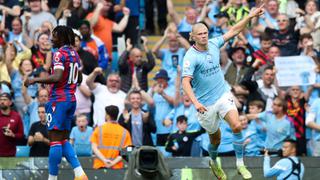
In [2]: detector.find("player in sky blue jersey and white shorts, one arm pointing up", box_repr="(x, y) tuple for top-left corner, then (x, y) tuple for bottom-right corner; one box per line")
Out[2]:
(182, 5), (264, 179)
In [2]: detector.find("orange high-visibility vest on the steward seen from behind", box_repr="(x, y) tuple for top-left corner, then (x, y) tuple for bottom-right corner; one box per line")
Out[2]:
(91, 122), (132, 169)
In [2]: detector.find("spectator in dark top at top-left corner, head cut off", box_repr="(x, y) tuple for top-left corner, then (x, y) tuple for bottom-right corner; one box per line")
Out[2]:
(0, 0), (21, 30)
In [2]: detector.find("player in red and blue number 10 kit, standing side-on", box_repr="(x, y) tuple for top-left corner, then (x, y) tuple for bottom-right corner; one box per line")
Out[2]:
(24, 26), (88, 180)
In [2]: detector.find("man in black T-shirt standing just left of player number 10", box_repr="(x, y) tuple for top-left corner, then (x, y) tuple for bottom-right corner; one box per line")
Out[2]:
(28, 104), (50, 157)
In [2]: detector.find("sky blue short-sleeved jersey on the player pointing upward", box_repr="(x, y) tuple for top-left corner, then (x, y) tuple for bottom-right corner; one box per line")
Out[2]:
(182, 36), (229, 106)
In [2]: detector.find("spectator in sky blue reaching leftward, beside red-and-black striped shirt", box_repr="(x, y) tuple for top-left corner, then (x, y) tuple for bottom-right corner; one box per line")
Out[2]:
(246, 97), (295, 152)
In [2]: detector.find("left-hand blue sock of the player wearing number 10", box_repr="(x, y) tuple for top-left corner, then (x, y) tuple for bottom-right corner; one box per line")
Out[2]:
(49, 142), (62, 176)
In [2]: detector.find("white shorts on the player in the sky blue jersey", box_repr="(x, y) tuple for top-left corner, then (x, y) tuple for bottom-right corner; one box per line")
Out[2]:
(198, 92), (237, 134)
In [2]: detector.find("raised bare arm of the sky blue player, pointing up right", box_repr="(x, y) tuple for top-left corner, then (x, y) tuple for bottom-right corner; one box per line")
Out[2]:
(223, 4), (264, 42)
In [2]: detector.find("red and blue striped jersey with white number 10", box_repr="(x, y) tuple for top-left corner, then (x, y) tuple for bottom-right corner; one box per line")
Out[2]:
(50, 46), (80, 102)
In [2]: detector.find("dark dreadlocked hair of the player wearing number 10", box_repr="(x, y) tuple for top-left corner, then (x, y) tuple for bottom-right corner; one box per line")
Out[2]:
(52, 26), (75, 46)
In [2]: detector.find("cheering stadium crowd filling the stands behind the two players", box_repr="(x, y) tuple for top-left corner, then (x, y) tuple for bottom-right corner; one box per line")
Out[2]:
(0, 0), (320, 169)
